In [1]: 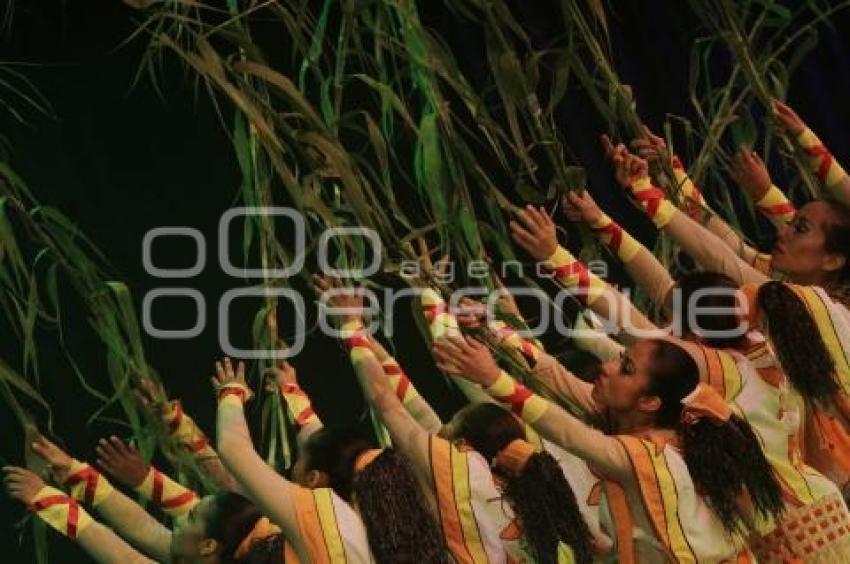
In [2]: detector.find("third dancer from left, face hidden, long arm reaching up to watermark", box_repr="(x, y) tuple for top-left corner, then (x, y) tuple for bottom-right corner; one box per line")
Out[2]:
(316, 277), (590, 563)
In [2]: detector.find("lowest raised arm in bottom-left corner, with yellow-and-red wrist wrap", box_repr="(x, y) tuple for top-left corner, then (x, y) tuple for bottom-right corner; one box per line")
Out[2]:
(3, 466), (157, 564)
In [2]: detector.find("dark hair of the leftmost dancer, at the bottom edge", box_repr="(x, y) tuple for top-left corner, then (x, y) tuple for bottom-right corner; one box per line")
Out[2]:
(205, 492), (284, 564)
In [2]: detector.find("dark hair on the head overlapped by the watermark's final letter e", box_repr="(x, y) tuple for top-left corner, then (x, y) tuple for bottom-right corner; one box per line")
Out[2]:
(677, 271), (746, 349)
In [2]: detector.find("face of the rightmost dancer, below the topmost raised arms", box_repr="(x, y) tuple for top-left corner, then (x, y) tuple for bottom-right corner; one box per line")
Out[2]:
(773, 200), (846, 285)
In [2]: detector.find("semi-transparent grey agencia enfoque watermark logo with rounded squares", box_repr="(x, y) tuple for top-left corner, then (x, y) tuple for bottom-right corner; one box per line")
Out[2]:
(142, 207), (749, 359)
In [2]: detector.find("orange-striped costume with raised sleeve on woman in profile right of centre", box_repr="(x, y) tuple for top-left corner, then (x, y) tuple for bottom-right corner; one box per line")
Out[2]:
(480, 373), (744, 563)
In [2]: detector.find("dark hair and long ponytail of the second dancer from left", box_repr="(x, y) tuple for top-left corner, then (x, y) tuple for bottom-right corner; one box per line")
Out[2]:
(303, 427), (451, 564)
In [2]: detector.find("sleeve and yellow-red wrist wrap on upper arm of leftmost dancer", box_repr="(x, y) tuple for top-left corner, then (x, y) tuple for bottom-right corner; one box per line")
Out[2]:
(65, 460), (171, 562)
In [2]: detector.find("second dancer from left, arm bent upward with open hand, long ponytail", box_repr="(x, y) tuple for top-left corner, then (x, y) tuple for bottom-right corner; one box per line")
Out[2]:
(213, 359), (448, 562)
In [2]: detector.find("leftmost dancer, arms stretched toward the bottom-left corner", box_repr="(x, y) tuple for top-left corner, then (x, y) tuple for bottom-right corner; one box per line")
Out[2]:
(4, 438), (284, 564)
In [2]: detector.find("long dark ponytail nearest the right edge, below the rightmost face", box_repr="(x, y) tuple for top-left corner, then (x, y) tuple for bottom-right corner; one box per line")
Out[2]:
(757, 282), (841, 404)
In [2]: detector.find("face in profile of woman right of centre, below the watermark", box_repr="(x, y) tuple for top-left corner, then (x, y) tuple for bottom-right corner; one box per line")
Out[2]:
(592, 340), (660, 414)
